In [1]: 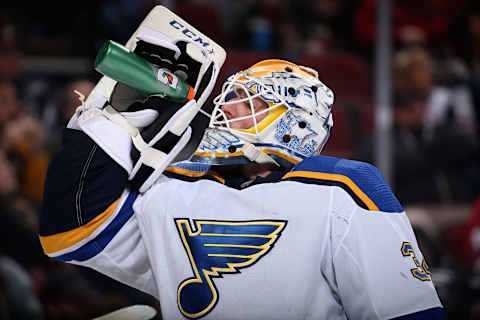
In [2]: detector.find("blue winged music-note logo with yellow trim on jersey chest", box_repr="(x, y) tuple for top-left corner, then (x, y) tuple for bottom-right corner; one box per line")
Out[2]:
(175, 219), (287, 319)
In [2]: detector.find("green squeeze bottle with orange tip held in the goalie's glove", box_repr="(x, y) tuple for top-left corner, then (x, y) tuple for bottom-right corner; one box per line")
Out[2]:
(94, 40), (194, 101)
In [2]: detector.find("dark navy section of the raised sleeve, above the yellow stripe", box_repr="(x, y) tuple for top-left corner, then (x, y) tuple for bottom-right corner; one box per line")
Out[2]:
(39, 128), (128, 240)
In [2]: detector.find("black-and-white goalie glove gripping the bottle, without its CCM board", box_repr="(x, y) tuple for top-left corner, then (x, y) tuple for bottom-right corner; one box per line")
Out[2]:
(72, 34), (220, 192)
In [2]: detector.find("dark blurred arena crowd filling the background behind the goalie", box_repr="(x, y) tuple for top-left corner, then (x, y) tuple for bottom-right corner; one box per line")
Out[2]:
(0, 0), (480, 319)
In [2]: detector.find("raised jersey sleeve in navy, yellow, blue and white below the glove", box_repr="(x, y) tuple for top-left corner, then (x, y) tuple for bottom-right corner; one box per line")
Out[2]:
(39, 128), (157, 296)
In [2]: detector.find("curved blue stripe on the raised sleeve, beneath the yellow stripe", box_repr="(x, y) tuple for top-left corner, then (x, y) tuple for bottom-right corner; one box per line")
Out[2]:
(54, 192), (138, 262)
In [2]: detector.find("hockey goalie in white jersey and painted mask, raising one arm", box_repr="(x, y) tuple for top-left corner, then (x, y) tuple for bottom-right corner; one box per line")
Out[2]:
(39, 5), (444, 320)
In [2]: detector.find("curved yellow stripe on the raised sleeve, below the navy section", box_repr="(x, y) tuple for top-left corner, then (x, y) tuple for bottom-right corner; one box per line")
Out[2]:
(39, 198), (120, 254)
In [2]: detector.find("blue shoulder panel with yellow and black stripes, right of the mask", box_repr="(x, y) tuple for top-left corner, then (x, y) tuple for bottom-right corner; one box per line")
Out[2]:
(283, 156), (403, 212)
